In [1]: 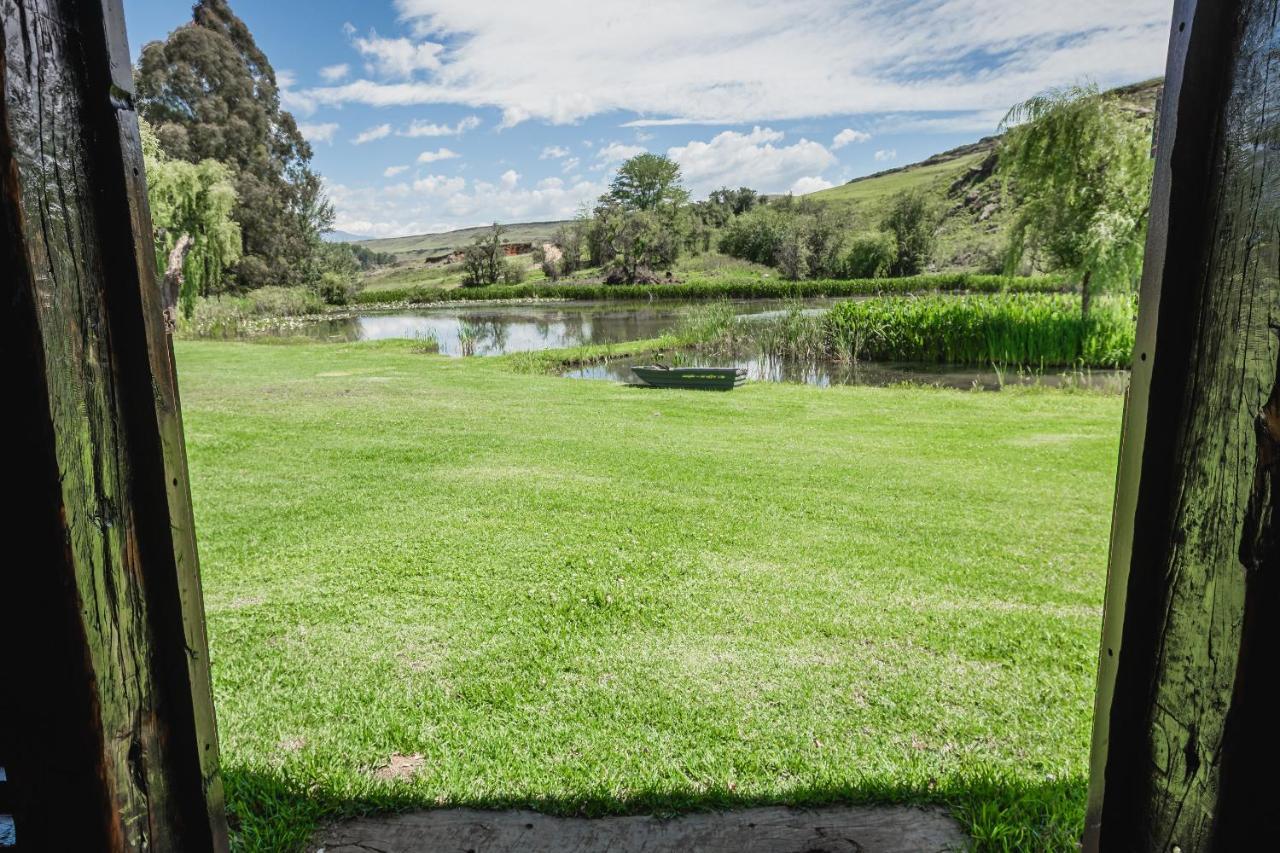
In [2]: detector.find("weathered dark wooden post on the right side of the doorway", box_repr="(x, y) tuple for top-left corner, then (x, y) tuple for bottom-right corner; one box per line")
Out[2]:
(1085, 0), (1280, 853)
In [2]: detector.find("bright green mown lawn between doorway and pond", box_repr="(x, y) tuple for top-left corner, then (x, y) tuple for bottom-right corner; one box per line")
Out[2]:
(178, 342), (1121, 849)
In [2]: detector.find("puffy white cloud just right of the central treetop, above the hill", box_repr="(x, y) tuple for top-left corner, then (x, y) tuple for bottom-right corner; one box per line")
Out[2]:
(667, 127), (836, 196)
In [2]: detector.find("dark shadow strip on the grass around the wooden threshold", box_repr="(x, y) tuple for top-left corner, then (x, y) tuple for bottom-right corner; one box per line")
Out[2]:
(224, 770), (1087, 853)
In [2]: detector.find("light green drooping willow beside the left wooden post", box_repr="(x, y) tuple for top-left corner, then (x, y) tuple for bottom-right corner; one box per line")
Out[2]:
(141, 122), (241, 318)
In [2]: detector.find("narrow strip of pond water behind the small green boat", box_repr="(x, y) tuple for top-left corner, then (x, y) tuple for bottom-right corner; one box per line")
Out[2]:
(561, 352), (1129, 393)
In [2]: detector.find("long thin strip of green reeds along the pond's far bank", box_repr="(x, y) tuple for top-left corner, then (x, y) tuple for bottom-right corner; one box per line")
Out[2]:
(355, 273), (1065, 305)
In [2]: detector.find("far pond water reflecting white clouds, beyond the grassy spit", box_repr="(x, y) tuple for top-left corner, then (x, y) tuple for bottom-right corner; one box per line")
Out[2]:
(254, 300), (846, 356)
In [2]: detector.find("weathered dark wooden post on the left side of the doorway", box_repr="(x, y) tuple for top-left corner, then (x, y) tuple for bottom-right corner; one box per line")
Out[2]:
(0, 0), (227, 852)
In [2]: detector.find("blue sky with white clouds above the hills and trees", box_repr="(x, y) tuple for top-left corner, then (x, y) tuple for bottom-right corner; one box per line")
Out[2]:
(124, 0), (1172, 237)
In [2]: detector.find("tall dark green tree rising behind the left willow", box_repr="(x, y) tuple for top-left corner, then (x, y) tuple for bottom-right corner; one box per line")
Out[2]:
(136, 0), (333, 287)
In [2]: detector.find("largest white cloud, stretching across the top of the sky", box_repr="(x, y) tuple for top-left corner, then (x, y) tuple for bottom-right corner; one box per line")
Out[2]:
(296, 0), (1169, 126)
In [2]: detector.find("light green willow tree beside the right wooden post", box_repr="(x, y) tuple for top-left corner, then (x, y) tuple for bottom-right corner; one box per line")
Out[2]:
(997, 86), (1153, 318)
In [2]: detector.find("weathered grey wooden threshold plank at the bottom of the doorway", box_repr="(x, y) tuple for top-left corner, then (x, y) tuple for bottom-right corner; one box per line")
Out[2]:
(312, 806), (969, 853)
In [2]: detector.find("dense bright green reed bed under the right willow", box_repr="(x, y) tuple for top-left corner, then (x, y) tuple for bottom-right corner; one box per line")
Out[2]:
(827, 293), (1137, 368)
